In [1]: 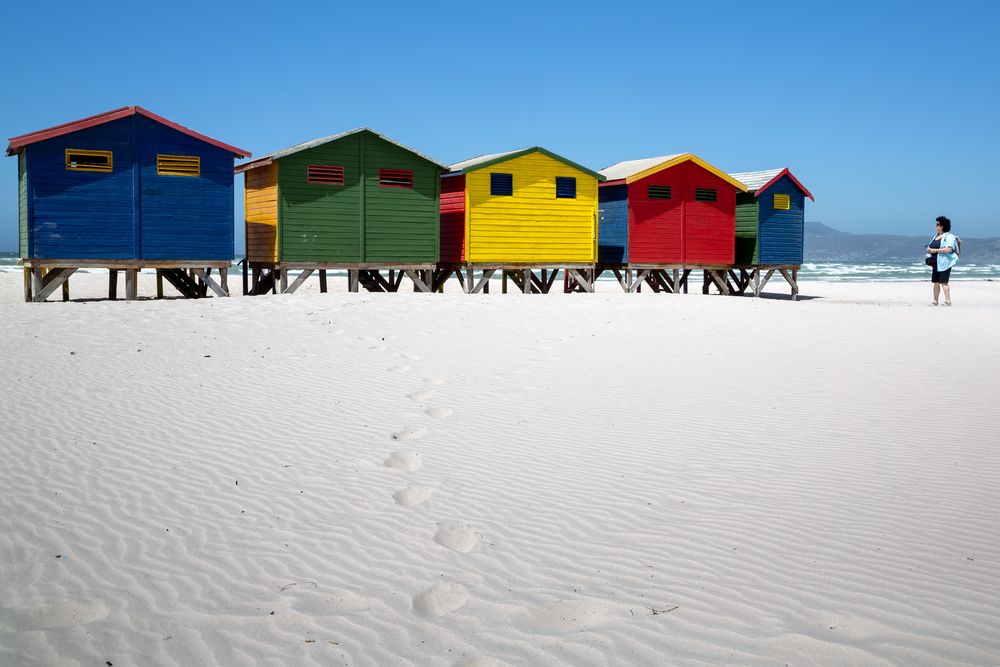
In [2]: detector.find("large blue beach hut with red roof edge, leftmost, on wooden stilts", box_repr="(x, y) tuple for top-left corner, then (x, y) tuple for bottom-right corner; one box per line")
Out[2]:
(7, 106), (250, 301)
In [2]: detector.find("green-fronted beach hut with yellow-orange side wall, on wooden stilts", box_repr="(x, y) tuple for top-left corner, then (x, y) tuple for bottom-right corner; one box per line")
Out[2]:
(236, 128), (446, 294)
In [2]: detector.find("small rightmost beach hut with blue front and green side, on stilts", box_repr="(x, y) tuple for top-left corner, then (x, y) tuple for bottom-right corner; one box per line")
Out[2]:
(730, 167), (815, 298)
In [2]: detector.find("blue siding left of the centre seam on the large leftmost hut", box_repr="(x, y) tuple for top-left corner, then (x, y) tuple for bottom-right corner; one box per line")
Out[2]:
(25, 118), (139, 259)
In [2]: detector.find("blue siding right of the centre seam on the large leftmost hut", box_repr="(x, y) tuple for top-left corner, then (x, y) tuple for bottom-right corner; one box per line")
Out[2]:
(133, 116), (234, 260)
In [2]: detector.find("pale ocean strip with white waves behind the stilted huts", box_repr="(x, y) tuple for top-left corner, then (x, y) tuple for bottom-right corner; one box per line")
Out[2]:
(0, 252), (1000, 282)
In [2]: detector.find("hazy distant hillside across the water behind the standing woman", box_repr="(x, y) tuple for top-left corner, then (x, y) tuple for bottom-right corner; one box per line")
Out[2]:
(805, 222), (1000, 264)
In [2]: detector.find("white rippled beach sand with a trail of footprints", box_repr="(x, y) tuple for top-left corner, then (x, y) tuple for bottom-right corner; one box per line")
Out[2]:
(0, 273), (1000, 666)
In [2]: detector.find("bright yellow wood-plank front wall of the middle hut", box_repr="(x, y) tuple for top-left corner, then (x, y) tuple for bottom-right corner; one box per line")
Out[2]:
(466, 153), (597, 264)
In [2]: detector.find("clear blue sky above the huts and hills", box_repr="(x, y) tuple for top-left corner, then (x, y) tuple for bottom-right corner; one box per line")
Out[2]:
(0, 0), (1000, 250)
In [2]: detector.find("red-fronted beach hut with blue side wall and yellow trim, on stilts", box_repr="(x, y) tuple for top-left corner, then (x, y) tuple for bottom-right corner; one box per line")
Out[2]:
(598, 153), (746, 291)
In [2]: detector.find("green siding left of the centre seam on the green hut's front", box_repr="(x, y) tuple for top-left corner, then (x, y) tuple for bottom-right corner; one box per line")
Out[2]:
(278, 134), (364, 263)
